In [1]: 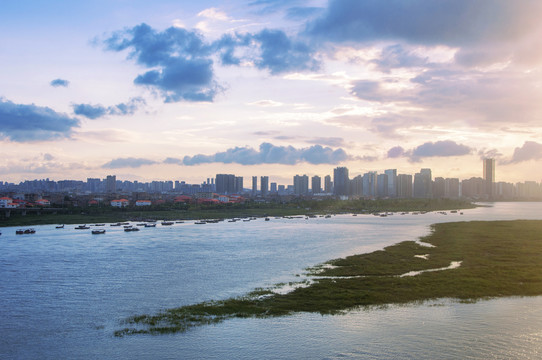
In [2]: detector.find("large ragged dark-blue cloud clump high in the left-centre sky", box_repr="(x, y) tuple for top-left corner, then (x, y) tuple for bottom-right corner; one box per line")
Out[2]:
(104, 24), (319, 102)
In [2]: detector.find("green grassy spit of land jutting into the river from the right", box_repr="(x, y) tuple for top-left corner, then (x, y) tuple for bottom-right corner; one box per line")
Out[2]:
(115, 220), (542, 336)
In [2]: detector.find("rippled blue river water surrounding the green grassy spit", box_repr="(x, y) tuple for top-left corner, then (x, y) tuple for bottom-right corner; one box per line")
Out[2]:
(0, 203), (542, 359)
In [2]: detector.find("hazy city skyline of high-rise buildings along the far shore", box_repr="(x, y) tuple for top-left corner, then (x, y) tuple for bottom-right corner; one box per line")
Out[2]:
(0, 159), (542, 208)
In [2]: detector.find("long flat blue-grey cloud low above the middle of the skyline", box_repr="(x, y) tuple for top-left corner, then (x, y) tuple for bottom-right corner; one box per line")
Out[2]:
(183, 143), (348, 165)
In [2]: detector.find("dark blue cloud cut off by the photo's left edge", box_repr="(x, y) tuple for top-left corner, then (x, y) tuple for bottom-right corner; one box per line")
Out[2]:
(0, 98), (79, 142)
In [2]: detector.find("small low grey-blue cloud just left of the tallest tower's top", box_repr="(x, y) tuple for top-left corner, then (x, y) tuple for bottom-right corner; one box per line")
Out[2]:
(387, 140), (473, 162)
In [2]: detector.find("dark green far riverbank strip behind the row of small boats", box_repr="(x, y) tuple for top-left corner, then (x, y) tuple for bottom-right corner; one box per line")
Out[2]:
(0, 199), (476, 227)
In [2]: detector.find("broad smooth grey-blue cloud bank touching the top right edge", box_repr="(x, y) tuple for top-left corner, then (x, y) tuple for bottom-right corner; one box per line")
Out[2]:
(306, 0), (542, 46)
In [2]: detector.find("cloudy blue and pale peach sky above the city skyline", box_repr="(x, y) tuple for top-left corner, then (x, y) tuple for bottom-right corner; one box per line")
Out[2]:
(0, 0), (542, 186)
